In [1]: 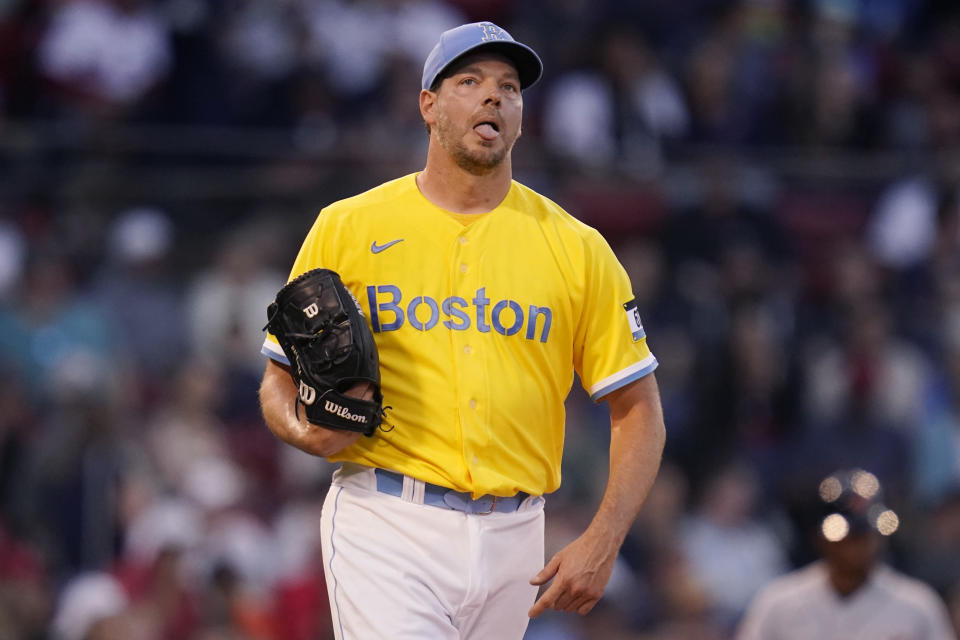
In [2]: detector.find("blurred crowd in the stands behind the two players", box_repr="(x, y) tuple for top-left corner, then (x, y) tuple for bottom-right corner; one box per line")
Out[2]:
(0, 0), (960, 640)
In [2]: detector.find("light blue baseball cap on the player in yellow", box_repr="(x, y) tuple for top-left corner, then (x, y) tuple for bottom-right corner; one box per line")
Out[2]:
(421, 22), (543, 89)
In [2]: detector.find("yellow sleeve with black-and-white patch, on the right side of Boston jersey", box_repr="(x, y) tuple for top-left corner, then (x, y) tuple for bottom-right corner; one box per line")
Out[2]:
(574, 229), (658, 401)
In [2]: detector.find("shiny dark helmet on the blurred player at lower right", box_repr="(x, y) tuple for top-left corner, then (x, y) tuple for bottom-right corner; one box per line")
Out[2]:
(819, 469), (900, 542)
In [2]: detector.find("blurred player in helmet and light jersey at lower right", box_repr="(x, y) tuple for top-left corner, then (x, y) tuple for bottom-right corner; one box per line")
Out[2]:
(737, 469), (956, 640)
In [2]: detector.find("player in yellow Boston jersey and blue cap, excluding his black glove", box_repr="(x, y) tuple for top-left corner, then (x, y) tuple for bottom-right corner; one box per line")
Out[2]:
(260, 22), (665, 640)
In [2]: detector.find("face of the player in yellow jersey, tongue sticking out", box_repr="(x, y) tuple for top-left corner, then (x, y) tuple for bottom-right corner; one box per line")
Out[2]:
(432, 54), (523, 175)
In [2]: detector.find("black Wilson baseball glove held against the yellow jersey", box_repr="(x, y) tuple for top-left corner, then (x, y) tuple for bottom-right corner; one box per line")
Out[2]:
(264, 269), (384, 436)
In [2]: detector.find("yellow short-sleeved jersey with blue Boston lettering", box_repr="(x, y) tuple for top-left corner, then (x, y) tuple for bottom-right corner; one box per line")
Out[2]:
(263, 174), (657, 497)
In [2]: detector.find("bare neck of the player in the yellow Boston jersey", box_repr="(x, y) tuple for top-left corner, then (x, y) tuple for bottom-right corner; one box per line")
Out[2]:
(417, 147), (513, 213)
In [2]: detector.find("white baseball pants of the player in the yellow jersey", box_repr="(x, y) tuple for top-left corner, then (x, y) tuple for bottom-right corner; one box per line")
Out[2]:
(321, 464), (544, 640)
